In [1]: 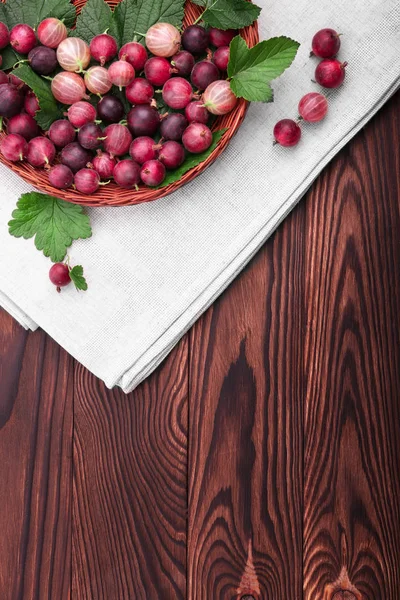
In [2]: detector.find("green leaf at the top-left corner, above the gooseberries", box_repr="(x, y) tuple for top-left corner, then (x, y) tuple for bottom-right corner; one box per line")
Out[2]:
(4, 0), (76, 28)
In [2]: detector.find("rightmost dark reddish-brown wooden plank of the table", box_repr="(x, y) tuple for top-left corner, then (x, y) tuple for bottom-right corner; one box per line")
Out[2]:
(304, 95), (400, 600)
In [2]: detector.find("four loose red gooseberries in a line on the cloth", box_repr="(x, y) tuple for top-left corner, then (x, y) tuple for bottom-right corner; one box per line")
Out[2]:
(274, 28), (347, 148)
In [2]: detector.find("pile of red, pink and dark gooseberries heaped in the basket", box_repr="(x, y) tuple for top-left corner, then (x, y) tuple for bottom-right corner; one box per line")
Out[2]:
(0, 17), (241, 195)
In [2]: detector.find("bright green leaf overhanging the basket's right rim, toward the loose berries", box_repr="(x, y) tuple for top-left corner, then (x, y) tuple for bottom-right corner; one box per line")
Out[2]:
(228, 35), (300, 102)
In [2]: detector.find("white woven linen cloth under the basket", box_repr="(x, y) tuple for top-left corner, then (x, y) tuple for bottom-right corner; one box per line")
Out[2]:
(0, 0), (400, 391)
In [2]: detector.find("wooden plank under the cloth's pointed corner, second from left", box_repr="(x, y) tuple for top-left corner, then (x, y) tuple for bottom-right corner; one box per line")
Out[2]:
(72, 340), (188, 600)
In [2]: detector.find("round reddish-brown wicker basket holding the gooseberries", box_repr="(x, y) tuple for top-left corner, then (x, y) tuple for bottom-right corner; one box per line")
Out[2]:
(0, 0), (259, 206)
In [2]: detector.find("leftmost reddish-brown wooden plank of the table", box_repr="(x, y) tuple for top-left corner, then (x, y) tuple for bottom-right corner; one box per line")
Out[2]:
(0, 311), (73, 600)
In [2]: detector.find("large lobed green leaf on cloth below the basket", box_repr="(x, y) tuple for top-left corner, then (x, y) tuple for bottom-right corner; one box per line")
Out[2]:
(8, 192), (92, 262)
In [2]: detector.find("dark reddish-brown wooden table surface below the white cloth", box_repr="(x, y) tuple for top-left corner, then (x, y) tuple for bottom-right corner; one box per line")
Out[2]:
(0, 94), (400, 600)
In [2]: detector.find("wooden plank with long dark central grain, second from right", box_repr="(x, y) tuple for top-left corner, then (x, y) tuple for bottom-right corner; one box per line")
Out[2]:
(188, 210), (304, 600)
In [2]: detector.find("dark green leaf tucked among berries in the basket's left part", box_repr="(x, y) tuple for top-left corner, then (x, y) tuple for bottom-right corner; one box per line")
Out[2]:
(13, 65), (64, 131)
